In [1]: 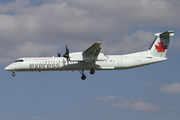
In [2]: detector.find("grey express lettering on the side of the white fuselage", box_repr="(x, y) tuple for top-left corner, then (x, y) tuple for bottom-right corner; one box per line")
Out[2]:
(30, 63), (60, 69)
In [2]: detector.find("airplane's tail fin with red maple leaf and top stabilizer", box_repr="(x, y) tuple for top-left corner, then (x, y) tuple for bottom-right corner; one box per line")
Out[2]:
(148, 31), (174, 57)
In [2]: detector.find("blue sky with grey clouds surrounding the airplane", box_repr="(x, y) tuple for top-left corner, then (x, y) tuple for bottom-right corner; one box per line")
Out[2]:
(0, 0), (180, 120)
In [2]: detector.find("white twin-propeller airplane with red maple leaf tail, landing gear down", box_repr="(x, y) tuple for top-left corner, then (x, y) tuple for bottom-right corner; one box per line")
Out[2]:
(5, 31), (174, 80)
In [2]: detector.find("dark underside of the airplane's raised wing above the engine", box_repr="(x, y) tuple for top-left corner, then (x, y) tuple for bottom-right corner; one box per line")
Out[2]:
(83, 42), (102, 56)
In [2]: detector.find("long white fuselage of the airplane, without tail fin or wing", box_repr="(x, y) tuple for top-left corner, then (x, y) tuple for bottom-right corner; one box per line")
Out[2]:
(5, 51), (167, 71)
